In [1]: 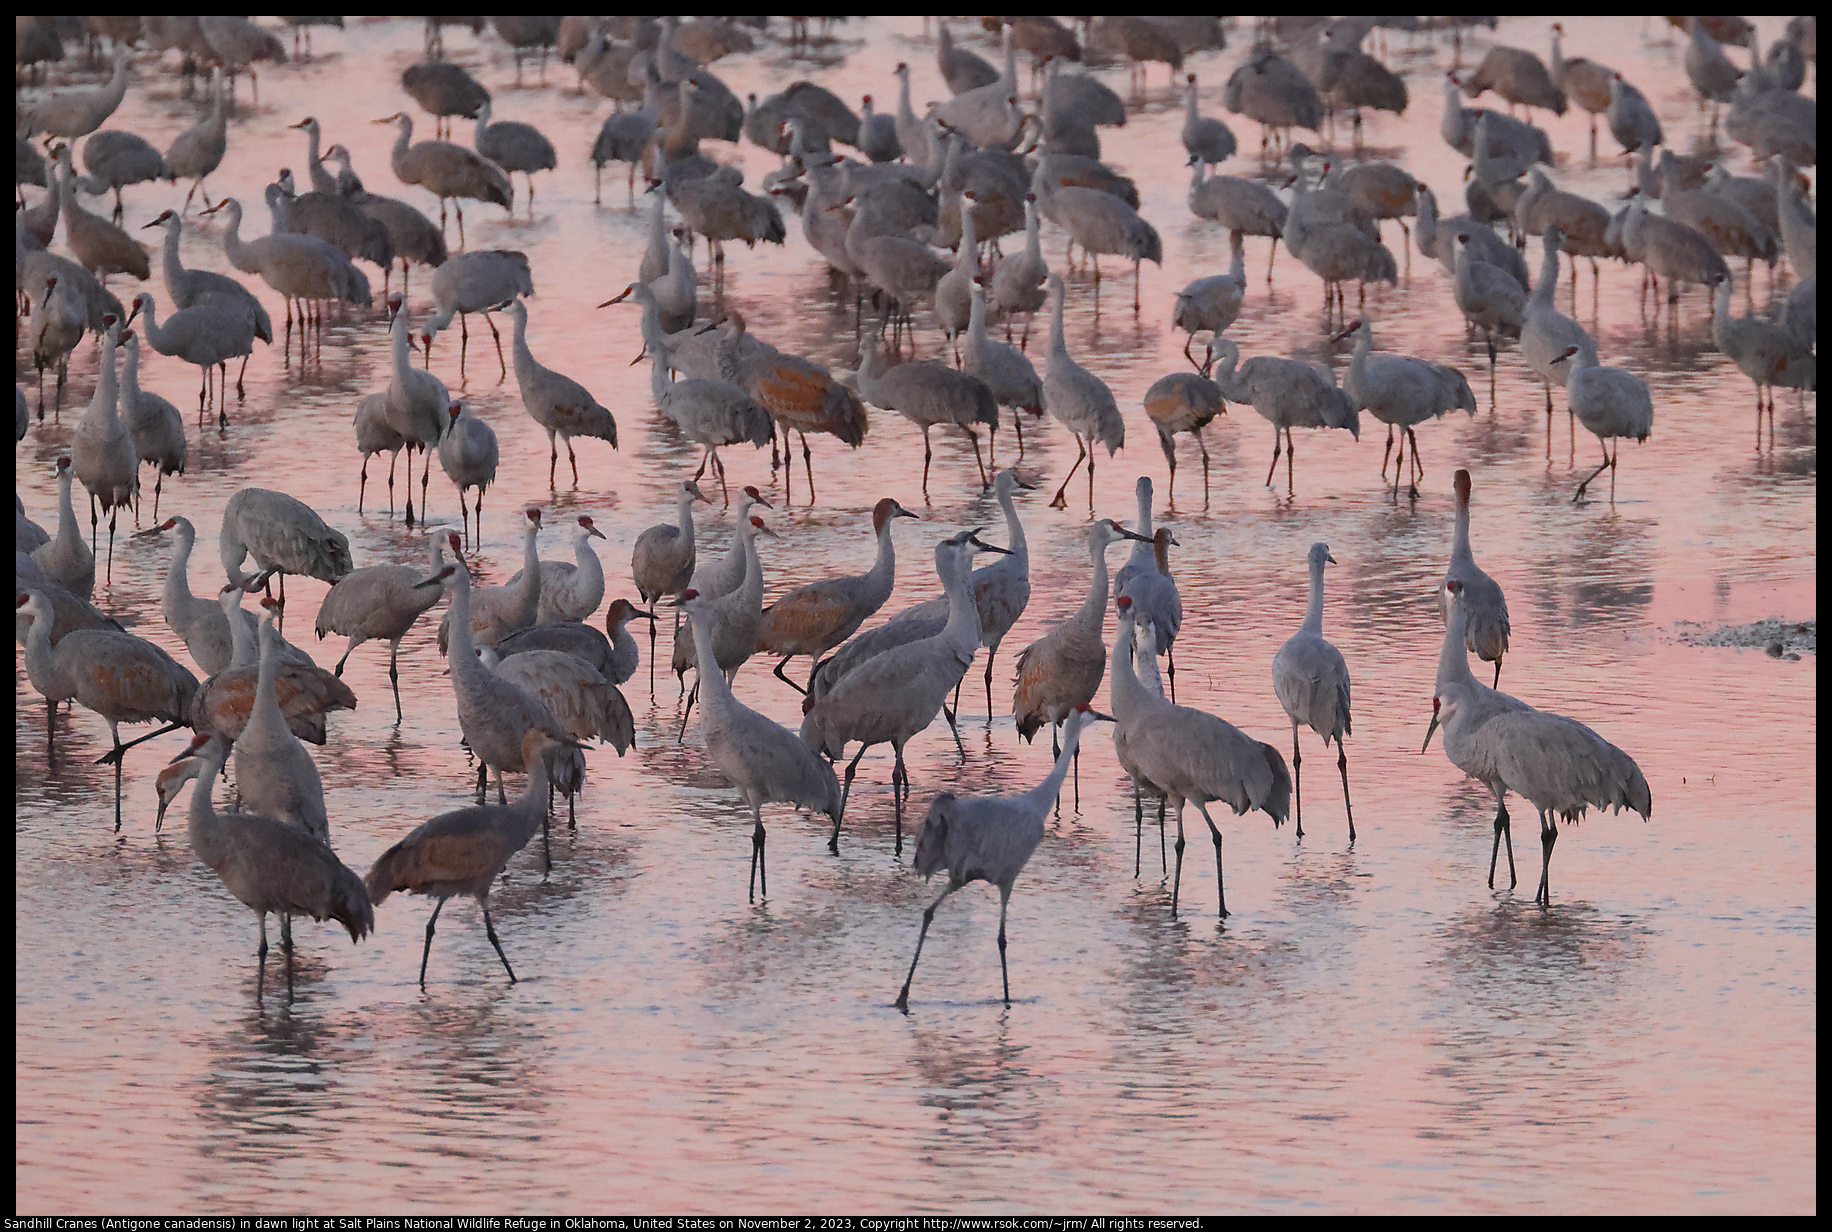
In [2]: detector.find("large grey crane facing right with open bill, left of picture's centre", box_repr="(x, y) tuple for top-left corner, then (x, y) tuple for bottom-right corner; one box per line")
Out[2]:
(801, 532), (1004, 853)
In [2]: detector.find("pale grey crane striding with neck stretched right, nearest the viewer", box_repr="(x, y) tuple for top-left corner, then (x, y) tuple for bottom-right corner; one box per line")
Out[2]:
(896, 702), (1112, 1014)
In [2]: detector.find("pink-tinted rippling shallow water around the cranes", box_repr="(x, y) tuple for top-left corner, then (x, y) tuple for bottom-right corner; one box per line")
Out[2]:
(15, 18), (1817, 1214)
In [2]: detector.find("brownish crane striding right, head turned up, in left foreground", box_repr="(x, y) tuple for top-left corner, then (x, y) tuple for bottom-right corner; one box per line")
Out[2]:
(365, 726), (577, 986)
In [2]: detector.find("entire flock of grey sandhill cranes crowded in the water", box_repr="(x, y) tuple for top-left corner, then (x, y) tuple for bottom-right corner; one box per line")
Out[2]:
(18, 17), (1816, 1008)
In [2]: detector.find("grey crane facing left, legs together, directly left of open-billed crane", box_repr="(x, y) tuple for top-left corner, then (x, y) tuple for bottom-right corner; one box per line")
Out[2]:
(678, 587), (845, 902)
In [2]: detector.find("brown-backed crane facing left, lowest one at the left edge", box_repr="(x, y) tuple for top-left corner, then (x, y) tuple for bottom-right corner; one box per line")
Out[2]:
(16, 590), (198, 832)
